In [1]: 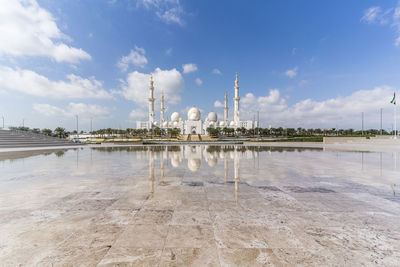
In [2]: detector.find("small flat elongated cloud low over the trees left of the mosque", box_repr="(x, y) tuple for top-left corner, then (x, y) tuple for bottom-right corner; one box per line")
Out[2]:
(33, 103), (110, 118)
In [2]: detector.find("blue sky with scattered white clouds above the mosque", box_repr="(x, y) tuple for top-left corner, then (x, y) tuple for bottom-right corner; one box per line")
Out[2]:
(0, 0), (400, 129)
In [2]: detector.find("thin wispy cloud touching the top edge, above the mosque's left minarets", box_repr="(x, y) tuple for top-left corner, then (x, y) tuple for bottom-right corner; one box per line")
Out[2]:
(137, 0), (185, 26)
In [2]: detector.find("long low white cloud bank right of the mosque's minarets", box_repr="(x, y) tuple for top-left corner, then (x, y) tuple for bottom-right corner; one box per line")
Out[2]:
(236, 86), (394, 128)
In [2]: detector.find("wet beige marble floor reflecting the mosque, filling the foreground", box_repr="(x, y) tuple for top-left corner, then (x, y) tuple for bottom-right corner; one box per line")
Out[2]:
(0, 146), (400, 266)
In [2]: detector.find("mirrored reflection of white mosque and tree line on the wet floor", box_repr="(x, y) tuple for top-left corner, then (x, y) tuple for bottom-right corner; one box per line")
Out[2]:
(93, 145), (322, 202)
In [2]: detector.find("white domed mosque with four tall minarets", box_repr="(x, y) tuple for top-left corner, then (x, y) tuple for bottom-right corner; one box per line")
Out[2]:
(136, 73), (257, 135)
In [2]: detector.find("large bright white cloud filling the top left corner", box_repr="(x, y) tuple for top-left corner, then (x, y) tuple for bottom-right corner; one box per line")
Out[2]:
(0, 0), (91, 63)
